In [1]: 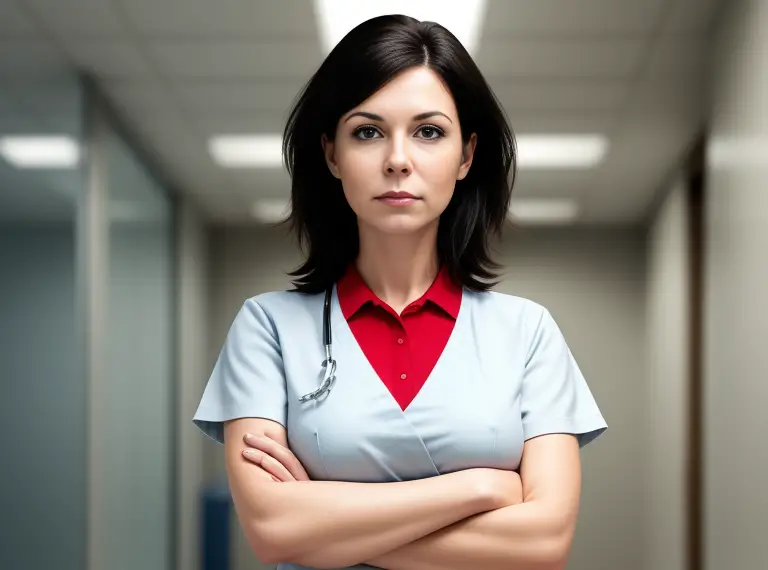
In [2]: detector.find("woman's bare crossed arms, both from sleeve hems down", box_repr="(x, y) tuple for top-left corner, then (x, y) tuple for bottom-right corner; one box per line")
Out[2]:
(225, 418), (581, 570)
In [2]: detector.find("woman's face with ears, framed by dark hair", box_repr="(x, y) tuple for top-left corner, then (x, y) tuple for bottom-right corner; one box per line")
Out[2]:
(322, 67), (476, 234)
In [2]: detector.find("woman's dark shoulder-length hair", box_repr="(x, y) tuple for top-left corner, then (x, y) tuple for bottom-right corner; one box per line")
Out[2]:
(283, 15), (516, 293)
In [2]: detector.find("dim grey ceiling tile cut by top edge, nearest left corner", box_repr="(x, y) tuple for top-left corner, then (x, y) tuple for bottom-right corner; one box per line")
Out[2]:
(24, 0), (126, 38)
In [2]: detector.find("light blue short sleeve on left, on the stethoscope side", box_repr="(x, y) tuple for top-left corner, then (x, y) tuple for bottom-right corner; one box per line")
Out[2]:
(193, 299), (287, 443)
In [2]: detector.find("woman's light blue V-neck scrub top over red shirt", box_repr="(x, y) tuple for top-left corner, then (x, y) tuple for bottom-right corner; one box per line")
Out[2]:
(194, 290), (606, 570)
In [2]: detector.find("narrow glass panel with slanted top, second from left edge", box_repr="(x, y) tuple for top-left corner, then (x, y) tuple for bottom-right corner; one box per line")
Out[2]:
(100, 121), (174, 570)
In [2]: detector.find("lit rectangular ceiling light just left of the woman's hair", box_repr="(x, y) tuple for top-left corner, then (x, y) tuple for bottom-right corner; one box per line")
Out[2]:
(208, 134), (283, 168)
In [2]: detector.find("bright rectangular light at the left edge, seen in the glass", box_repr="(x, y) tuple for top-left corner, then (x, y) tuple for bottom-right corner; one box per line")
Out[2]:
(0, 135), (80, 168)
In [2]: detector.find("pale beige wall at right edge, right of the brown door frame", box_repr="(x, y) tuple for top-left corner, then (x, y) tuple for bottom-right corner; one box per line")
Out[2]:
(704, 0), (768, 570)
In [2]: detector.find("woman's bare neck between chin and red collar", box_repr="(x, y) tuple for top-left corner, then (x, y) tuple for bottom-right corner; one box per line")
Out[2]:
(356, 223), (440, 314)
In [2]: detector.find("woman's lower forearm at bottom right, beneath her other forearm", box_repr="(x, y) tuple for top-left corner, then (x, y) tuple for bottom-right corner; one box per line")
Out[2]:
(368, 501), (572, 570)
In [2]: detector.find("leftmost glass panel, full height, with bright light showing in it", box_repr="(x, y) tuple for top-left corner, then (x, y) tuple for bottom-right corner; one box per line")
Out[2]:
(0, 74), (87, 570)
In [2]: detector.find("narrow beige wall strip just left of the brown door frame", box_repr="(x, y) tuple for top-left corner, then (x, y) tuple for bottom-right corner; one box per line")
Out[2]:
(645, 175), (691, 570)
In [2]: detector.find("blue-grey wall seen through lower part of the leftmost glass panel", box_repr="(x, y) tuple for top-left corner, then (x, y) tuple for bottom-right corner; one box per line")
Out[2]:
(0, 223), (86, 570)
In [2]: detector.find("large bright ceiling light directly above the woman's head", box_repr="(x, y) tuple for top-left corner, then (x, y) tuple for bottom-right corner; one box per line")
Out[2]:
(315, 0), (486, 53)
